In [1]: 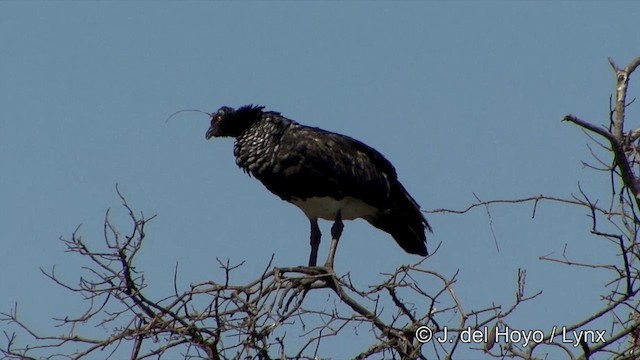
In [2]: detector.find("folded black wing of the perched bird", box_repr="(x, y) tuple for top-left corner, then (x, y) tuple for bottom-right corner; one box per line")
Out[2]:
(254, 124), (397, 207)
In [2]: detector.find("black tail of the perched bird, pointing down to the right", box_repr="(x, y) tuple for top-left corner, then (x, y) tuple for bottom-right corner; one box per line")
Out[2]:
(366, 189), (431, 256)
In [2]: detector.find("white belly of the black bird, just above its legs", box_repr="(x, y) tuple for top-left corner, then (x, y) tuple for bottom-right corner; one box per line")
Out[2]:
(289, 196), (378, 220)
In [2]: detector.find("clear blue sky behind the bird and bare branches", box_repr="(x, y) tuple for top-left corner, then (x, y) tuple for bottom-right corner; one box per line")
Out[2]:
(0, 1), (640, 357)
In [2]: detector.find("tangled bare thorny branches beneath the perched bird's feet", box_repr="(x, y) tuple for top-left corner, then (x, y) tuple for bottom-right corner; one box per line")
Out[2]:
(0, 191), (537, 359)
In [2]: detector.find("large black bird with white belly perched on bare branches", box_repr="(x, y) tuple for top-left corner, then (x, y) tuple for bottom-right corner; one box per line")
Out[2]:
(206, 105), (431, 268)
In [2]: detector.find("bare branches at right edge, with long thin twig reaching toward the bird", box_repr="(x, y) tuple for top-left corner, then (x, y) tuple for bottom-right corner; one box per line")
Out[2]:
(430, 57), (640, 359)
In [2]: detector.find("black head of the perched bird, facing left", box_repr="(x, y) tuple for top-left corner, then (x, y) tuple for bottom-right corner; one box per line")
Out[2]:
(206, 105), (264, 139)
